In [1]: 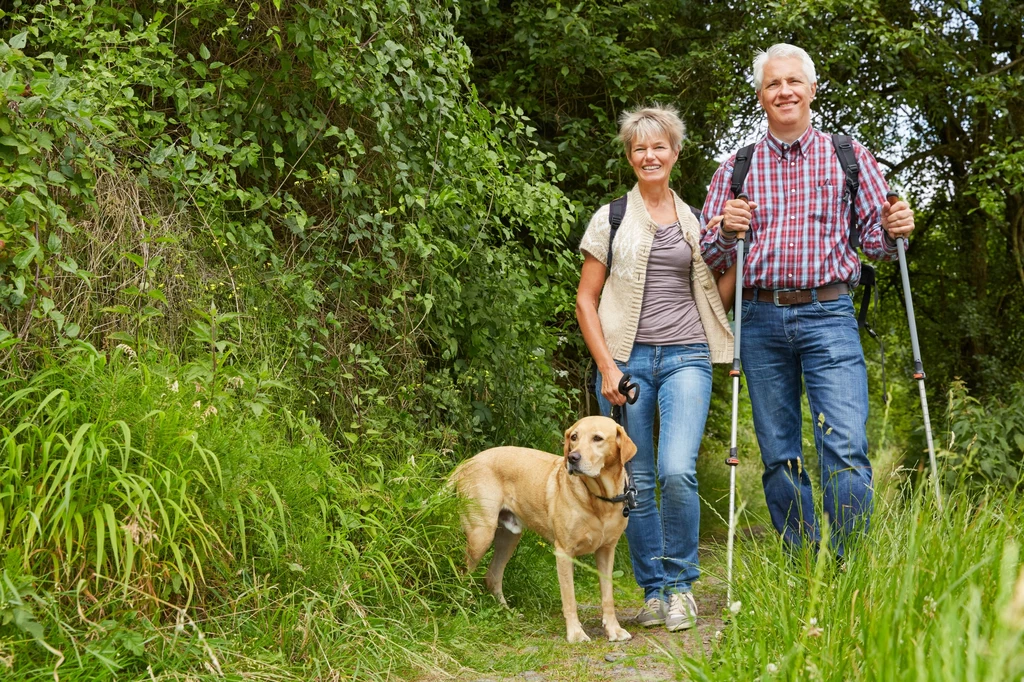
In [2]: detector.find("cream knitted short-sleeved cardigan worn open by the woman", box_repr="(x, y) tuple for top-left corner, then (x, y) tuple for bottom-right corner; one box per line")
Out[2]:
(580, 180), (732, 363)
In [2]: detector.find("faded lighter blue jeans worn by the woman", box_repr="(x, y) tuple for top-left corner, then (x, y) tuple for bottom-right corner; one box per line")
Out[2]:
(598, 343), (712, 601)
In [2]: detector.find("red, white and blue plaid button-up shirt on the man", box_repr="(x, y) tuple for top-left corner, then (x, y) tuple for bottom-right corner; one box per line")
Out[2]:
(701, 128), (896, 289)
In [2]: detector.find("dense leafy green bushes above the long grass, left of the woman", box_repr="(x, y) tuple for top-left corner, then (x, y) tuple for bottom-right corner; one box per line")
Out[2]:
(0, 1), (572, 446)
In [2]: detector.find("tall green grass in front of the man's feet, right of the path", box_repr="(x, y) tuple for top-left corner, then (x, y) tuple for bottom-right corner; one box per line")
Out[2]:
(677, 481), (1024, 680)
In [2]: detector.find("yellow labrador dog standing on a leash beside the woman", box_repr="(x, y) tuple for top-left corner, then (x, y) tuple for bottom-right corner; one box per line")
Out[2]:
(452, 417), (637, 643)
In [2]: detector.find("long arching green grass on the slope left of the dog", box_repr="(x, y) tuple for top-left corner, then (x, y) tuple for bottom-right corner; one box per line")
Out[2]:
(0, 344), (472, 680)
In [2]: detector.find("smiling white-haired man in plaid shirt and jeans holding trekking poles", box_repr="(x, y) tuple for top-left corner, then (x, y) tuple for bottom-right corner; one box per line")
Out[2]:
(701, 44), (913, 555)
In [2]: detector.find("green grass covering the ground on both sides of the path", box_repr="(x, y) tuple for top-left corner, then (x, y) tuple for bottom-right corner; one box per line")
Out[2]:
(0, 344), (1024, 680)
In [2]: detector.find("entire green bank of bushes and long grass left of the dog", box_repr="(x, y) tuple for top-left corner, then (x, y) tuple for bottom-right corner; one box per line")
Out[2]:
(0, 0), (589, 679)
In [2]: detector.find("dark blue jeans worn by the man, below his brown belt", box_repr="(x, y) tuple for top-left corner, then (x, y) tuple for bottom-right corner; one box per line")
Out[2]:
(740, 295), (872, 555)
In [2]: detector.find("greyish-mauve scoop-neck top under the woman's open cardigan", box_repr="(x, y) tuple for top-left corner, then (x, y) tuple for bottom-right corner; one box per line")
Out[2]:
(636, 222), (708, 346)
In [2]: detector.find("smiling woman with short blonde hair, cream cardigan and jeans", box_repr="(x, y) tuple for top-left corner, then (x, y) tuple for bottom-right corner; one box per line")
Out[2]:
(577, 106), (732, 631)
